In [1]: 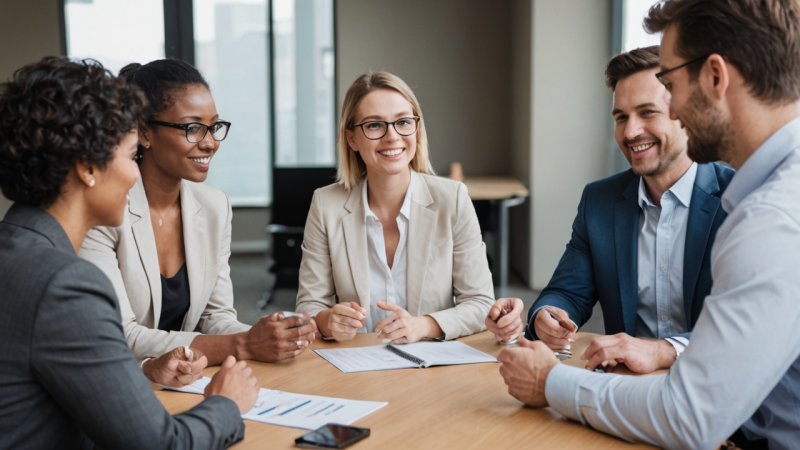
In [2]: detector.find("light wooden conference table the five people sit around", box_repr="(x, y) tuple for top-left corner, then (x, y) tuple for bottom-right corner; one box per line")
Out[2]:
(156, 332), (652, 450)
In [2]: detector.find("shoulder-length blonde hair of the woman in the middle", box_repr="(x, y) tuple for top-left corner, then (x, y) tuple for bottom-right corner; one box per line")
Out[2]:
(336, 72), (433, 191)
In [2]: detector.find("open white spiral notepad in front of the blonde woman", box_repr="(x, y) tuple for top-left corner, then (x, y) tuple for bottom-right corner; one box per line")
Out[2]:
(314, 341), (497, 373)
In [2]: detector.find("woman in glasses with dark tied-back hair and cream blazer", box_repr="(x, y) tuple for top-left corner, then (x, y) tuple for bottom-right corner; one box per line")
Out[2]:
(81, 59), (316, 365)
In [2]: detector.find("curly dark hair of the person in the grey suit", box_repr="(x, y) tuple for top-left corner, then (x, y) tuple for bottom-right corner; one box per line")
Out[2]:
(0, 57), (146, 207)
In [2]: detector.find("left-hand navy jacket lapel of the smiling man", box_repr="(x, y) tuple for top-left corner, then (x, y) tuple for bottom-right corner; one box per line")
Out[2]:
(614, 177), (639, 334)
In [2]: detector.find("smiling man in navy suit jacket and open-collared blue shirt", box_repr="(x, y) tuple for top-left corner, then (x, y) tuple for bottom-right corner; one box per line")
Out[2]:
(486, 46), (734, 373)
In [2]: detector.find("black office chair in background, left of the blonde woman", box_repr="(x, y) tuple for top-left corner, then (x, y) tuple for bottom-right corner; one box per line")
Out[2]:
(258, 167), (336, 309)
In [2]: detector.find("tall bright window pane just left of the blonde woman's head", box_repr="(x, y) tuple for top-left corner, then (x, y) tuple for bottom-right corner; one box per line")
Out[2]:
(272, 0), (336, 167)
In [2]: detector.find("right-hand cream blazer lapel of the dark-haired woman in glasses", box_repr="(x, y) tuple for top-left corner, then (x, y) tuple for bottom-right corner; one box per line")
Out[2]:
(181, 181), (210, 329)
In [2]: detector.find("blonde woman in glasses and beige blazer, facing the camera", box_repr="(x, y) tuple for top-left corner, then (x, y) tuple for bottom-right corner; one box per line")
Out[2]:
(297, 72), (494, 343)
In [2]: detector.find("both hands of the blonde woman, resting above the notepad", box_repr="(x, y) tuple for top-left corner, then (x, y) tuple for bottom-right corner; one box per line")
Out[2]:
(317, 301), (443, 344)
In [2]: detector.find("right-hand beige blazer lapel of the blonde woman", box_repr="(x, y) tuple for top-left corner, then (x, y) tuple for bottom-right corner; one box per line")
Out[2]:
(406, 170), (436, 316)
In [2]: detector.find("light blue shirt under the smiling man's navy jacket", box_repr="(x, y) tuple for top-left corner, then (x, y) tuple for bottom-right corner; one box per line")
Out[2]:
(635, 163), (697, 338)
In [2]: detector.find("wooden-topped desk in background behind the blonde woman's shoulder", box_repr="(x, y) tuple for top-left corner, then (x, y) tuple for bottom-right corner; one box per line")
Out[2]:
(464, 177), (528, 298)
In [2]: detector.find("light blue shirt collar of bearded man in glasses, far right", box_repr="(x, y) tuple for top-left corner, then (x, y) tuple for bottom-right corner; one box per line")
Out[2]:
(722, 117), (800, 213)
